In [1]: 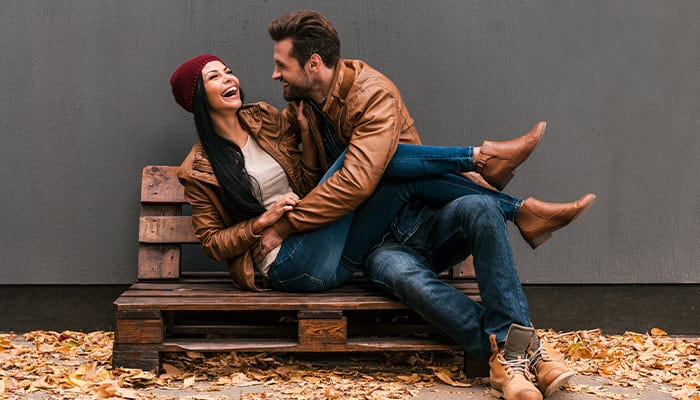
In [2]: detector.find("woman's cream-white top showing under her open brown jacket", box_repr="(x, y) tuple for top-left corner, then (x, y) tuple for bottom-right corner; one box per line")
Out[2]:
(241, 135), (293, 276)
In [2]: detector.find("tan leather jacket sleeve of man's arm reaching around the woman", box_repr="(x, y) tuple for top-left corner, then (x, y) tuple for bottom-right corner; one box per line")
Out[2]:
(274, 79), (402, 237)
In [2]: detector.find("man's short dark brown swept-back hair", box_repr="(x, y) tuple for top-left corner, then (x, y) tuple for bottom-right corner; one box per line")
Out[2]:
(268, 11), (340, 68)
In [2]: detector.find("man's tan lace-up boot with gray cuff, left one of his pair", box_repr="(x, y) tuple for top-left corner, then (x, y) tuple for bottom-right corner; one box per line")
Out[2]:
(489, 324), (542, 400)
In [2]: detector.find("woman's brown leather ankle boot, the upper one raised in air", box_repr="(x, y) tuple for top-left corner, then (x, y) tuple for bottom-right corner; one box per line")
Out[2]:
(474, 121), (547, 190)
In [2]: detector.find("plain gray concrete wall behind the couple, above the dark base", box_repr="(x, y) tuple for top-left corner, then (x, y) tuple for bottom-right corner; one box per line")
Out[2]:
(0, 0), (700, 284)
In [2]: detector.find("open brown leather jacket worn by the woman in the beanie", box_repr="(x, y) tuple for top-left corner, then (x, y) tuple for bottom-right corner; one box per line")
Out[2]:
(178, 102), (321, 290)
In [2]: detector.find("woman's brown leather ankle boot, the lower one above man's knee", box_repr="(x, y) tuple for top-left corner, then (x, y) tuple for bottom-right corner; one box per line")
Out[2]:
(515, 193), (595, 249)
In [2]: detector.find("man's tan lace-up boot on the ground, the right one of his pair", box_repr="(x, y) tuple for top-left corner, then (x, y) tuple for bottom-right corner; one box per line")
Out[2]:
(529, 339), (576, 397)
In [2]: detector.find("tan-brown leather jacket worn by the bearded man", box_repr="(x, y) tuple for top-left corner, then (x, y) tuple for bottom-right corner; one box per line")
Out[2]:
(274, 60), (420, 237)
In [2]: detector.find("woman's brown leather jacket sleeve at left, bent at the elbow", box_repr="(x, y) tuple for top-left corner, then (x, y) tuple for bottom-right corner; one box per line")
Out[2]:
(185, 180), (260, 261)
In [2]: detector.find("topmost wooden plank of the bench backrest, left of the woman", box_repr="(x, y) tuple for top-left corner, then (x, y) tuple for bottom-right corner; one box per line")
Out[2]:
(141, 165), (186, 203)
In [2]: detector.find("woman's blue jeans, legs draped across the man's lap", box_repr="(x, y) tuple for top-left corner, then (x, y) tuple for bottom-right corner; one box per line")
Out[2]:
(268, 144), (522, 292)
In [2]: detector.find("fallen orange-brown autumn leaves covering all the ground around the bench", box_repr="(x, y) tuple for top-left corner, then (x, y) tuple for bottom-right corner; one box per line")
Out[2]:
(0, 329), (700, 400)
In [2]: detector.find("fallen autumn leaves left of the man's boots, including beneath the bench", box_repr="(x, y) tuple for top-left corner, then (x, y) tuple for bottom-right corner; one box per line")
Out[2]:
(0, 331), (469, 400)
